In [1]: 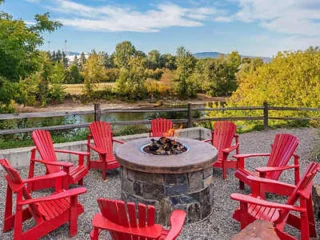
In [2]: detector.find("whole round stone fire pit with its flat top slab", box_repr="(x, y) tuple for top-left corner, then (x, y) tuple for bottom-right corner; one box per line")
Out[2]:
(115, 138), (217, 225)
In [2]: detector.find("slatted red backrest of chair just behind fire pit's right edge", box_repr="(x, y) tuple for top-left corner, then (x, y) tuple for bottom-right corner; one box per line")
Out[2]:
(212, 121), (237, 158)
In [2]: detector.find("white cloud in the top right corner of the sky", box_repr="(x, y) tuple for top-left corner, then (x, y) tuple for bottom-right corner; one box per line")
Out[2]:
(228, 0), (320, 36)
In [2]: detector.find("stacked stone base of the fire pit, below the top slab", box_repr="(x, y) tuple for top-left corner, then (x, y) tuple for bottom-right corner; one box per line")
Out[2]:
(121, 167), (213, 225)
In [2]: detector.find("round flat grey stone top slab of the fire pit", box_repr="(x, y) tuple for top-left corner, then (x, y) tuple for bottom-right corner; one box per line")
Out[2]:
(115, 138), (217, 174)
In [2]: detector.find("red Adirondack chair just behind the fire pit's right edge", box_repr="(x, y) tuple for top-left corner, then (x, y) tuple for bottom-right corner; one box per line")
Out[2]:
(205, 121), (239, 179)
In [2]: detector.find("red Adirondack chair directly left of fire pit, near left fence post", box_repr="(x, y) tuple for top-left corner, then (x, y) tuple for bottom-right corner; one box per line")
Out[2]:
(88, 121), (124, 180)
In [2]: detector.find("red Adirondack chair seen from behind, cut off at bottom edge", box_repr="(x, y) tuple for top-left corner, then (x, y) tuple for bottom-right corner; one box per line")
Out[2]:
(90, 198), (186, 240)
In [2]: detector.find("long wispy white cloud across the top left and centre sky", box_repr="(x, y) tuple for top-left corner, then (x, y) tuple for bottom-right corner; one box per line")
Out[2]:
(51, 0), (217, 32)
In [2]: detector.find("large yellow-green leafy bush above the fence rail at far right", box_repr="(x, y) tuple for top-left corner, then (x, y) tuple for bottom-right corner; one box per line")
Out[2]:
(229, 48), (320, 107)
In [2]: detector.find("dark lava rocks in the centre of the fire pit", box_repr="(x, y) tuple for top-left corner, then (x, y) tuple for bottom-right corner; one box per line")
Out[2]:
(143, 137), (188, 155)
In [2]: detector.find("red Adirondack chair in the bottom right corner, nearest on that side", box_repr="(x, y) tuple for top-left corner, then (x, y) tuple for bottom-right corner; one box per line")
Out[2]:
(231, 162), (320, 240)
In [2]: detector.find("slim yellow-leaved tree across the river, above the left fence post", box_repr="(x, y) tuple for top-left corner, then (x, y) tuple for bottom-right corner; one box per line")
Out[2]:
(82, 51), (106, 99)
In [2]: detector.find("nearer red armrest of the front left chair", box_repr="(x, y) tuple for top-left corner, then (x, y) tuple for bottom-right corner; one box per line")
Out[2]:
(18, 188), (87, 205)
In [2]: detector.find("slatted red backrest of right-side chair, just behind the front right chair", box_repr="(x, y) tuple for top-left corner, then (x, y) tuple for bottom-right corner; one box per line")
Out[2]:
(266, 134), (299, 180)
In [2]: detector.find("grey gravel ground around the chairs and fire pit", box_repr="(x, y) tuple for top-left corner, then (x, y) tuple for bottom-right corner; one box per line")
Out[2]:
(0, 128), (320, 240)
